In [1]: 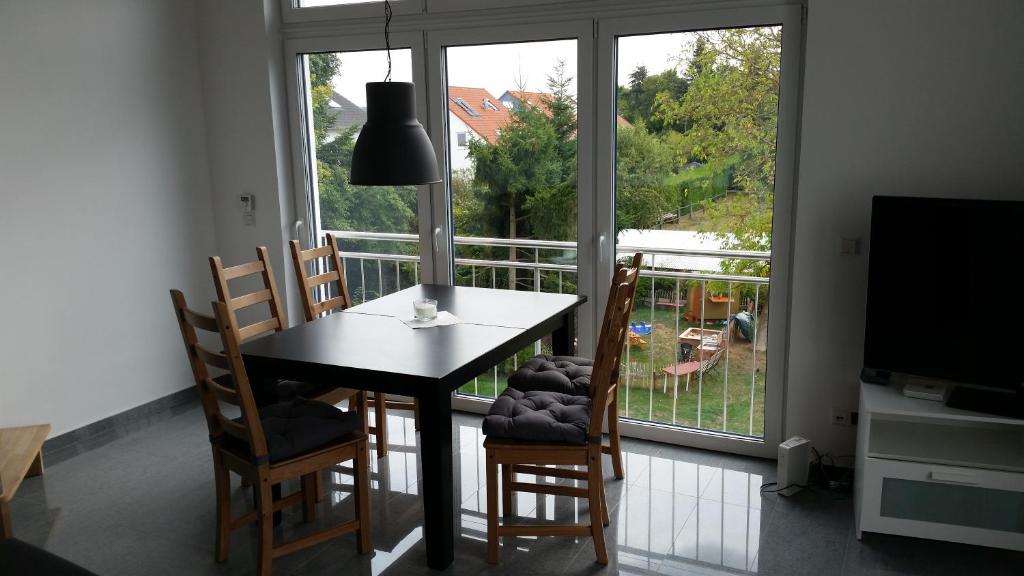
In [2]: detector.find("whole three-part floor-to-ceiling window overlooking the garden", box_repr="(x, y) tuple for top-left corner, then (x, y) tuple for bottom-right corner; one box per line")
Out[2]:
(286, 0), (800, 454)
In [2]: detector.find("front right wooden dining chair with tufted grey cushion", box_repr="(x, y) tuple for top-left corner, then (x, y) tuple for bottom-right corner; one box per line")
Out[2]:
(483, 253), (640, 565)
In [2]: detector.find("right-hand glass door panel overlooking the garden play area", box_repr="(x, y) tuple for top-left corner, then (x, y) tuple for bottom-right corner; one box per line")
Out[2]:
(598, 5), (799, 455)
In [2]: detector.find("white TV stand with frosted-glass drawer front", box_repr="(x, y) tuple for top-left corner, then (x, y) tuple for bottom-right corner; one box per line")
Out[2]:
(854, 382), (1024, 550)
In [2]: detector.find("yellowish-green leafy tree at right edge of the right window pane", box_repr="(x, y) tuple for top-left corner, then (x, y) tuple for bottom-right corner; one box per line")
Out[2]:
(657, 27), (782, 276)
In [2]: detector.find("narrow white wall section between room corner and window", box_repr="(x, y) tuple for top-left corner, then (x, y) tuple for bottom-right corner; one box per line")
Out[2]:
(198, 0), (304, 323)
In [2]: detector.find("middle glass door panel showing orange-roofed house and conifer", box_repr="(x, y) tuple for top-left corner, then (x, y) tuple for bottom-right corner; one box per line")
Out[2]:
(429, 23), (595, 405)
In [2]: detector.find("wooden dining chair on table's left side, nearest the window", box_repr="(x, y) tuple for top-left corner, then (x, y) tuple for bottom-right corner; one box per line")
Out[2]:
(290, 234), (420, 458)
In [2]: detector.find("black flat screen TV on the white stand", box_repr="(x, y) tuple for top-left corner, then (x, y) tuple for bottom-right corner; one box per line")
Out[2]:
(864, 196), (1024, 416)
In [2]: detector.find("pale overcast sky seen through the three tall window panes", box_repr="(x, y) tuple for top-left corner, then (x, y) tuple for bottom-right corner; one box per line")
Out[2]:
(327, 33), (692, 107)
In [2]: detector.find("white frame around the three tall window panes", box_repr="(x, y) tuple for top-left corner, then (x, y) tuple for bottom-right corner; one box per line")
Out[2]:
(282, 0), (804, 457)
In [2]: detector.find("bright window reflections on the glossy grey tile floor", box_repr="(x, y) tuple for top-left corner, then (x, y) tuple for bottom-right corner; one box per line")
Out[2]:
(321, 412), (764, 574)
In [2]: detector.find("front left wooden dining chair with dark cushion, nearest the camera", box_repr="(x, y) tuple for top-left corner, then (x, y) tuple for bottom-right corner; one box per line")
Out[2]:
(171, 290), (372, 576)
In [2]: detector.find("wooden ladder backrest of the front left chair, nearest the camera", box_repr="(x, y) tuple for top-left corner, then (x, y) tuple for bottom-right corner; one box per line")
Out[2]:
(171, 290), (267, 460)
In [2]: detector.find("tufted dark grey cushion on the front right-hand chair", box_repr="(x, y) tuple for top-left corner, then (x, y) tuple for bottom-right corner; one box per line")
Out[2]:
(483, 388), (590, 444)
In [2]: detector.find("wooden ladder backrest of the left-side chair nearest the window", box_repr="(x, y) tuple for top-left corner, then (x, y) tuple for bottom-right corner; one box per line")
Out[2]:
(290, 234), (352, 322)
